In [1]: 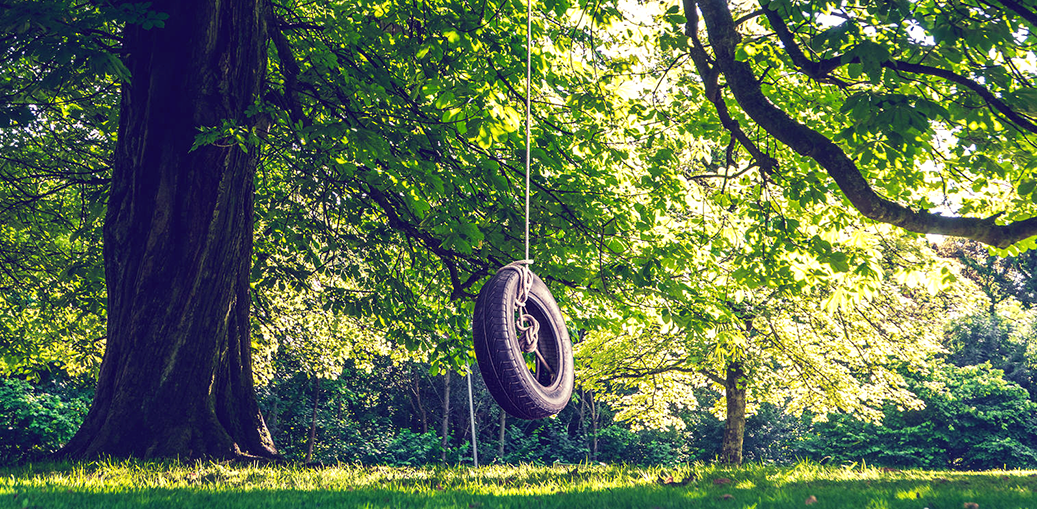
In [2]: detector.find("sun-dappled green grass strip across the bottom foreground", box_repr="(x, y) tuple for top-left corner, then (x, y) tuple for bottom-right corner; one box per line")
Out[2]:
(0, 460), (1037, 509)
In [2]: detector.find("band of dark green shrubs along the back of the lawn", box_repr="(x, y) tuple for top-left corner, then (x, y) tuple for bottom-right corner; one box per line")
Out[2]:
(0, 302), (1037, 470)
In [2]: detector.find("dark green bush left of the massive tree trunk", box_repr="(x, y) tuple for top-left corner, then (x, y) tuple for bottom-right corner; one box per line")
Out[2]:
(0, 378), (90, 462)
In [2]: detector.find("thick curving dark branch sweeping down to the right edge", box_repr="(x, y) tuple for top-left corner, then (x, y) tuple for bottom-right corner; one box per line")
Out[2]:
(699, 0), (1037, 248)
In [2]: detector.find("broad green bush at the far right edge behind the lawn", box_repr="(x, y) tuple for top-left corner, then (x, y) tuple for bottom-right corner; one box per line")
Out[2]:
(801, 364), (1037, 470)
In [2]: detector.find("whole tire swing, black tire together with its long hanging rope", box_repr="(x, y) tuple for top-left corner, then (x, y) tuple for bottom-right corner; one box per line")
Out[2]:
(472, 0), (573, 419)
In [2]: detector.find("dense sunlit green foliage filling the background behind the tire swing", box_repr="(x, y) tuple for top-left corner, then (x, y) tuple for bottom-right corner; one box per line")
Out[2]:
(0, 0), (1037, 468)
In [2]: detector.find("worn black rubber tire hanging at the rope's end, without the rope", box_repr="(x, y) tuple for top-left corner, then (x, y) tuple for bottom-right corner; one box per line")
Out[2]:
(472, 270), (573, 419)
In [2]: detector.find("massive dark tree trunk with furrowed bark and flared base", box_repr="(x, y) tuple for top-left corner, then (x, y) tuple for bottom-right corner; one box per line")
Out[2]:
(62, 0), (277, 457)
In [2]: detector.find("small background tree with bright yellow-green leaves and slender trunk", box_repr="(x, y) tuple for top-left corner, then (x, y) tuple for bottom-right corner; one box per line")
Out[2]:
(576, 230), (975, 463)
